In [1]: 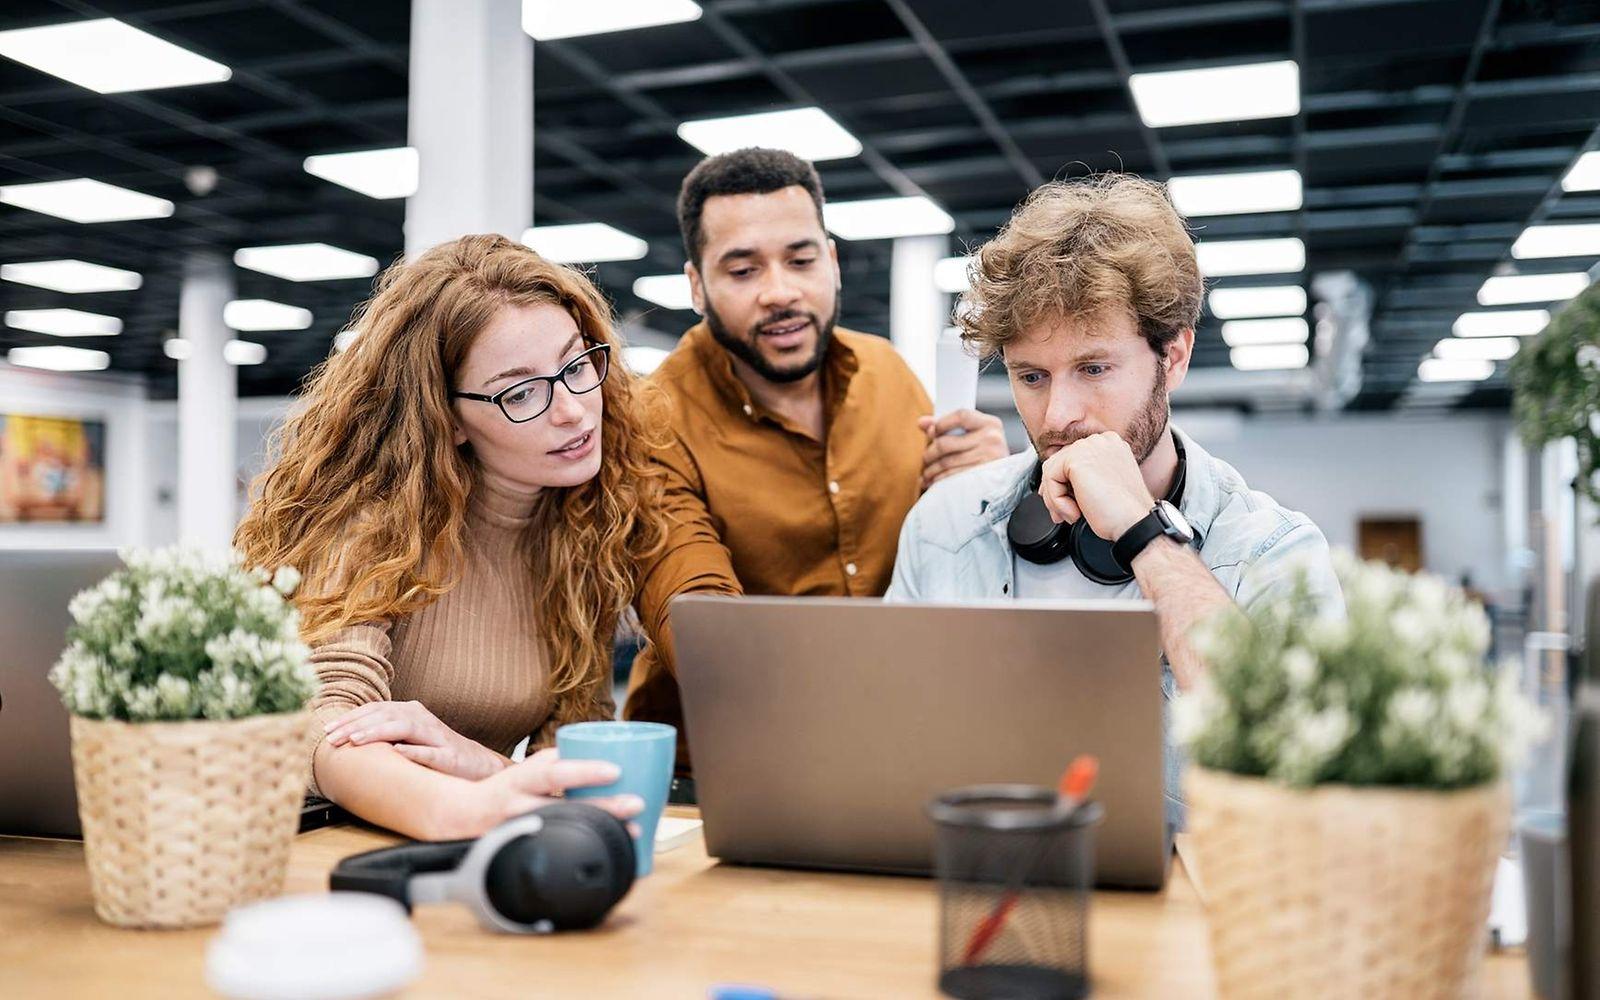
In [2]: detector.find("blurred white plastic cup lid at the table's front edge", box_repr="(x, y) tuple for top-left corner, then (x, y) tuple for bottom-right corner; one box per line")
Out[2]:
(205, 893), (422, 1000)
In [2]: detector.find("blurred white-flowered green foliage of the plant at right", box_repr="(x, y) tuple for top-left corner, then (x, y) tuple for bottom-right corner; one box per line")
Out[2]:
(1174, 554), (1539, 789)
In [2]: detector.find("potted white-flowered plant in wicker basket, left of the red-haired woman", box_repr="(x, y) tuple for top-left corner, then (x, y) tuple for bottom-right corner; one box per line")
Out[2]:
(50, 549), (317, 926)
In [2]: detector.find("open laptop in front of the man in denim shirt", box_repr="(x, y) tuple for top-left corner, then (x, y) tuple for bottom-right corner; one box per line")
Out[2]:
(672, 595), (1168, 888)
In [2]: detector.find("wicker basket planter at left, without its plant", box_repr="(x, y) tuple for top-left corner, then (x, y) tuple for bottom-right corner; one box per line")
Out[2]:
(72, 712), (310, 928)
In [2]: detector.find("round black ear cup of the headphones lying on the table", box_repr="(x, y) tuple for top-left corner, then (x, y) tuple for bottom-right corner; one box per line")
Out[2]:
(485, 802), (637, 931)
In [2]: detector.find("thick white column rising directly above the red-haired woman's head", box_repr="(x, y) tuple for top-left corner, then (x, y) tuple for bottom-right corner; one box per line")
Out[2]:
(405, 0), (533, 258)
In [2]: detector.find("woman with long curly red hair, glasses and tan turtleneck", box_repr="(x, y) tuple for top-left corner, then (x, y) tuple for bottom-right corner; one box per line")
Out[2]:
(235, 235), (664, 840)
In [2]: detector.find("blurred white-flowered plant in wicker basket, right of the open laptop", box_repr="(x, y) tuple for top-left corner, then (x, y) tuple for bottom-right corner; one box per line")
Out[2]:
(1176, 555), (1538, 1000)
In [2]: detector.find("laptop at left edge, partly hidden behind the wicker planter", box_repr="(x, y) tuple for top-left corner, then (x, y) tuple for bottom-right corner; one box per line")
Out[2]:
(0, 549), (349, 837)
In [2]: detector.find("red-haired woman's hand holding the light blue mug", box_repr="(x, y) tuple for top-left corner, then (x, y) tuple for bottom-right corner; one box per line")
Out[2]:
(430, 747), (645, 840)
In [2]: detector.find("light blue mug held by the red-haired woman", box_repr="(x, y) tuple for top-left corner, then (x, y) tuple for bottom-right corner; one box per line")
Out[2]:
(555, 722), (678, 875)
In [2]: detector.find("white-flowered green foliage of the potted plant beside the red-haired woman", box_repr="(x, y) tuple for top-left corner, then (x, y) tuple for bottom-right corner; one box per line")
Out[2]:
(50, 547), (317, 722)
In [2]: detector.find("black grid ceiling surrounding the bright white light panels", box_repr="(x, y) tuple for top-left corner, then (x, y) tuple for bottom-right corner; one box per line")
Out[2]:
(0, 0), (1600, 410)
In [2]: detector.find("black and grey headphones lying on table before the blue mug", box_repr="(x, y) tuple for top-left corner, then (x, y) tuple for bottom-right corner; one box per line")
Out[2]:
(328, 802), (637, 934)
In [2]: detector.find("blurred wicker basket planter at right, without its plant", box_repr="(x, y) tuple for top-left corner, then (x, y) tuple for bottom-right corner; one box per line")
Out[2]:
(1184, 766), (1510, 1000)
